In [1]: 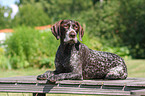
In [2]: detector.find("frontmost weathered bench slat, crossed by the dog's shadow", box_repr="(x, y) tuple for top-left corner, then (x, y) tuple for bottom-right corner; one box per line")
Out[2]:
(0, 85), (130, 95)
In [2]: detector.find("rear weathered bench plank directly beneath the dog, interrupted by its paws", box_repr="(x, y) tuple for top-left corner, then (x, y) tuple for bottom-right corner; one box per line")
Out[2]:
(0, 76), (145, 86)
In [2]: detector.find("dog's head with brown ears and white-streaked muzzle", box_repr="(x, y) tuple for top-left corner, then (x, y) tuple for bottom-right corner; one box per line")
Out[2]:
(51, 20), (84, 43)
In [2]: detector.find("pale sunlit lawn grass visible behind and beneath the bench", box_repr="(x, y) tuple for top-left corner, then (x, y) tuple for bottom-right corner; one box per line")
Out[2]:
(0, 59), (145, 96)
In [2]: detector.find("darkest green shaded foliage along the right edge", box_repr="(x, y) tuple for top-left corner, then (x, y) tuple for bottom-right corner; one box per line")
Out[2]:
(118, 0), (145, 58)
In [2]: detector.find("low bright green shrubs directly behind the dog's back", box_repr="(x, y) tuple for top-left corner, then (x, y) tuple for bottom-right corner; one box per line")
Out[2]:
(82, 33), (131, 59)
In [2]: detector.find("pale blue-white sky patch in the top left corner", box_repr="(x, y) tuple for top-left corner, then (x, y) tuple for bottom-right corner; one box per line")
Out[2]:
(0, 0), (19, 18)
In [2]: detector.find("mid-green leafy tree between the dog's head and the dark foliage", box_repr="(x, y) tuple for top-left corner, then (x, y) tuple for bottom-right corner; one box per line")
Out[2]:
(82, 0), (121, 47)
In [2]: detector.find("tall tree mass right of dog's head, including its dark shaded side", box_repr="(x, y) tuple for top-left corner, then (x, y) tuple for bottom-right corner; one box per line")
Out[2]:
(82, 0), (145, 58)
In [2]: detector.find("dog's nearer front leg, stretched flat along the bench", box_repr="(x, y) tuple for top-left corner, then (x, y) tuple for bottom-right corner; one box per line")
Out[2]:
(47, 73), (83, 82)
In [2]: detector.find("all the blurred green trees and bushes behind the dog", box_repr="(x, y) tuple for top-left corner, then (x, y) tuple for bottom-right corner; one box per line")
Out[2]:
(0, 0), (145, 72)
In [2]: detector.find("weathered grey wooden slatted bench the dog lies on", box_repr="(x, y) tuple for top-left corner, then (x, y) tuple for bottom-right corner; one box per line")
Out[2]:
(0, 76), (145, 96)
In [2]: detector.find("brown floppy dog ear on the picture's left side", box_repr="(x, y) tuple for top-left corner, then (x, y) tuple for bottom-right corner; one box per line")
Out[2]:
(51, 20), (63, 40)
